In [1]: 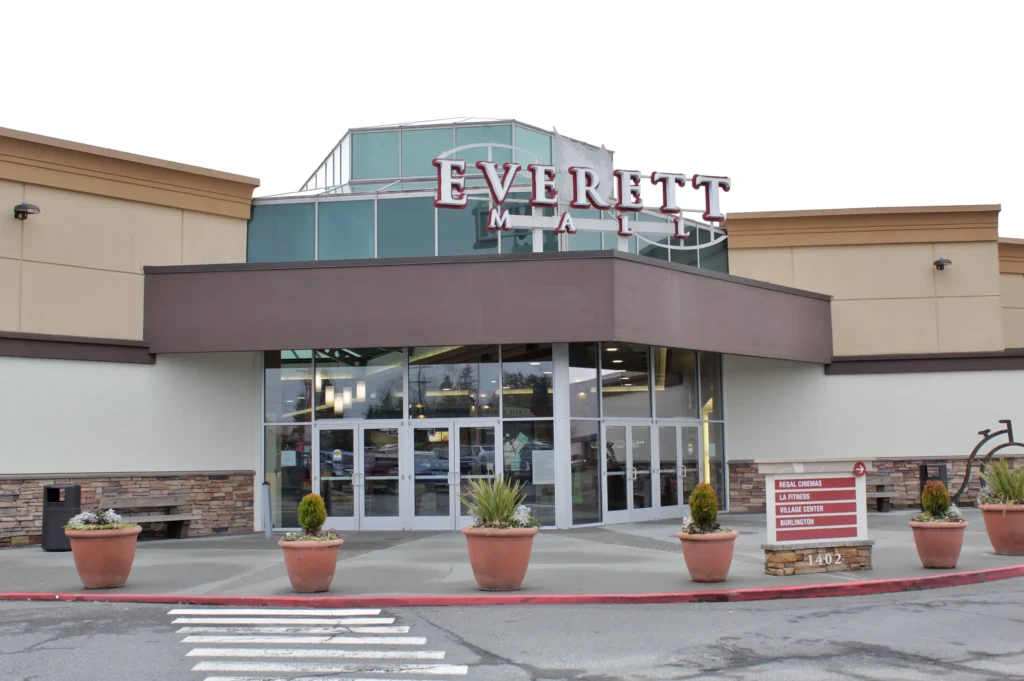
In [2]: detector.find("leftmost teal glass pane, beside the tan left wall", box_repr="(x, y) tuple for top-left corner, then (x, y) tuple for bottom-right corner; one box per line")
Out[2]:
(246, 201), (316, 262)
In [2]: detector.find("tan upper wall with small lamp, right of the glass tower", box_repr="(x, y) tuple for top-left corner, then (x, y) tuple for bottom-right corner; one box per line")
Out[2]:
(729, 242), (1003, 356)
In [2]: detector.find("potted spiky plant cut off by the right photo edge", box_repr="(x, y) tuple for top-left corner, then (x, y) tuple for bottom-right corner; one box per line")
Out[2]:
(978, 459), (1024, 556)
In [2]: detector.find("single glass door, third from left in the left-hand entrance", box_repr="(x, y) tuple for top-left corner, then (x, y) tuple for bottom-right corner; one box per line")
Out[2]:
(406, 421), (458, 529)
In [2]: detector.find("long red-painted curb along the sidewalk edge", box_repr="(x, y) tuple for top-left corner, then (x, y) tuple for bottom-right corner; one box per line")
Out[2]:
(0, 564), (1024, 607)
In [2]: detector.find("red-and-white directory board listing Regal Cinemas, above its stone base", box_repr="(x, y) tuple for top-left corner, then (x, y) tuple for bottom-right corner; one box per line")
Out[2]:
(766, 473), (867, 544)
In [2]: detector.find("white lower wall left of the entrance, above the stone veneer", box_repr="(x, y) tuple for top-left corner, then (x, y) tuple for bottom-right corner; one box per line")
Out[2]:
(0, 352), (262, 475)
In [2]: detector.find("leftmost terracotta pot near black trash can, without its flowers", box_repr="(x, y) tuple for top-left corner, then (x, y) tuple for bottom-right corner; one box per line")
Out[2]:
(65, 525), (142, 589)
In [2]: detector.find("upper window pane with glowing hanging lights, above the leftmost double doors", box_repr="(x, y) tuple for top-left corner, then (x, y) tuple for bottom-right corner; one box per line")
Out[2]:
(313, 347), (406, 419)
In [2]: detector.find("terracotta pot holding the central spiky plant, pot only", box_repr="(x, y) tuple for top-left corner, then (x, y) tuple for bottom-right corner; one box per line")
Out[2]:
(462, 527), (538, 591)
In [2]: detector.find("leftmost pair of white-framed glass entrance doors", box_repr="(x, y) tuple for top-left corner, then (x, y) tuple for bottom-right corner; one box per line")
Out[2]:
(313, 424), (401, 530)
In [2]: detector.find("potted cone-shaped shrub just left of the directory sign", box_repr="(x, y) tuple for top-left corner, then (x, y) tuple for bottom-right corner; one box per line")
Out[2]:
(676, 482), (739, 582)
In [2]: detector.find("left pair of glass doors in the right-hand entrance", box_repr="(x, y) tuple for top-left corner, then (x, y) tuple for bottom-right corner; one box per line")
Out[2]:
(604, 423), (658, 522)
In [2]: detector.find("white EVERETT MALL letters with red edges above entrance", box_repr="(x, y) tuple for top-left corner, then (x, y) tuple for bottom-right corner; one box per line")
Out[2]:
(433, 159), (732, 239)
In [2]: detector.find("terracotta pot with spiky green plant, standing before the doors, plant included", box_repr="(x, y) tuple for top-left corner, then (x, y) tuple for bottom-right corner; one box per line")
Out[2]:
(462, 478), (541, 591)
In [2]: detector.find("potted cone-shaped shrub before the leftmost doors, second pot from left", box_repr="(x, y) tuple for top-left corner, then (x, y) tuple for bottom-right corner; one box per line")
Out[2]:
(278, 495), (344, 594)
